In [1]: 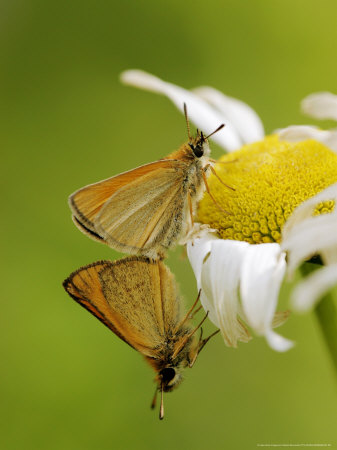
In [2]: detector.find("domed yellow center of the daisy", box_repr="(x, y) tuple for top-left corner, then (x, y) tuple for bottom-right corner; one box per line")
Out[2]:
(198, 135), (337, 244)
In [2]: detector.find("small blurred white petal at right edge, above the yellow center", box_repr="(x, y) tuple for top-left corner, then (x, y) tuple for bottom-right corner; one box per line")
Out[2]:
(301, 92), (337, 120)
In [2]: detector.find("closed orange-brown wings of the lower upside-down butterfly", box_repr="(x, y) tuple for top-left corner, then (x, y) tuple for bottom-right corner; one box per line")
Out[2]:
(63, 257), (179, 359)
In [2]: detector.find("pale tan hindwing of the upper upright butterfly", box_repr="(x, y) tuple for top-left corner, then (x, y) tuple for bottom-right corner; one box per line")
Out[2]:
(94, 161), (188, 253)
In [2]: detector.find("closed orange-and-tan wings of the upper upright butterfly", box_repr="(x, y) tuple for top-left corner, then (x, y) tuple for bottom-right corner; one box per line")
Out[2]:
(70, 159), (189, 254)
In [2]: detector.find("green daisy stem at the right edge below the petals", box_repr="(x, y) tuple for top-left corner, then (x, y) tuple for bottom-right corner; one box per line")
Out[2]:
(301, 263), (337, 374)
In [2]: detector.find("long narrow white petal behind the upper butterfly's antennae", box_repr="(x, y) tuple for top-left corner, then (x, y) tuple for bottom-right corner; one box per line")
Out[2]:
(120, 70), (242, 151)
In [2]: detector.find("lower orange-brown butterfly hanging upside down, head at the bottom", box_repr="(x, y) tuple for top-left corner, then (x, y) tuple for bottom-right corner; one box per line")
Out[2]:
(63, 256), (219, 419)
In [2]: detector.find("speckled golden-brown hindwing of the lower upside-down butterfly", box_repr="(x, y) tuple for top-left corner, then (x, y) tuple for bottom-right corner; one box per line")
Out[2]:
(100, 257), (177, 342)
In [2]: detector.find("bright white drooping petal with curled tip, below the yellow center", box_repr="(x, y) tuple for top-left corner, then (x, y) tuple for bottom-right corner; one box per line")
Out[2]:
(240, 244), (292, 351)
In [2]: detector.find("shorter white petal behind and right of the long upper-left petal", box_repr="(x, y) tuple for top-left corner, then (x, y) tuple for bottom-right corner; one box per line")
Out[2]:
(193, 86), (264, 144)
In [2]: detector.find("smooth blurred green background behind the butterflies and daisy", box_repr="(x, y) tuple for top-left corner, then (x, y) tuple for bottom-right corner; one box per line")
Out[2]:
(0, 0), (337, 450)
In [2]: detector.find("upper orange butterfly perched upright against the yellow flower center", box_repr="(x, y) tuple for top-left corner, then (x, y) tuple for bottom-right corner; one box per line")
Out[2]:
(69, 105), (224, 259)
